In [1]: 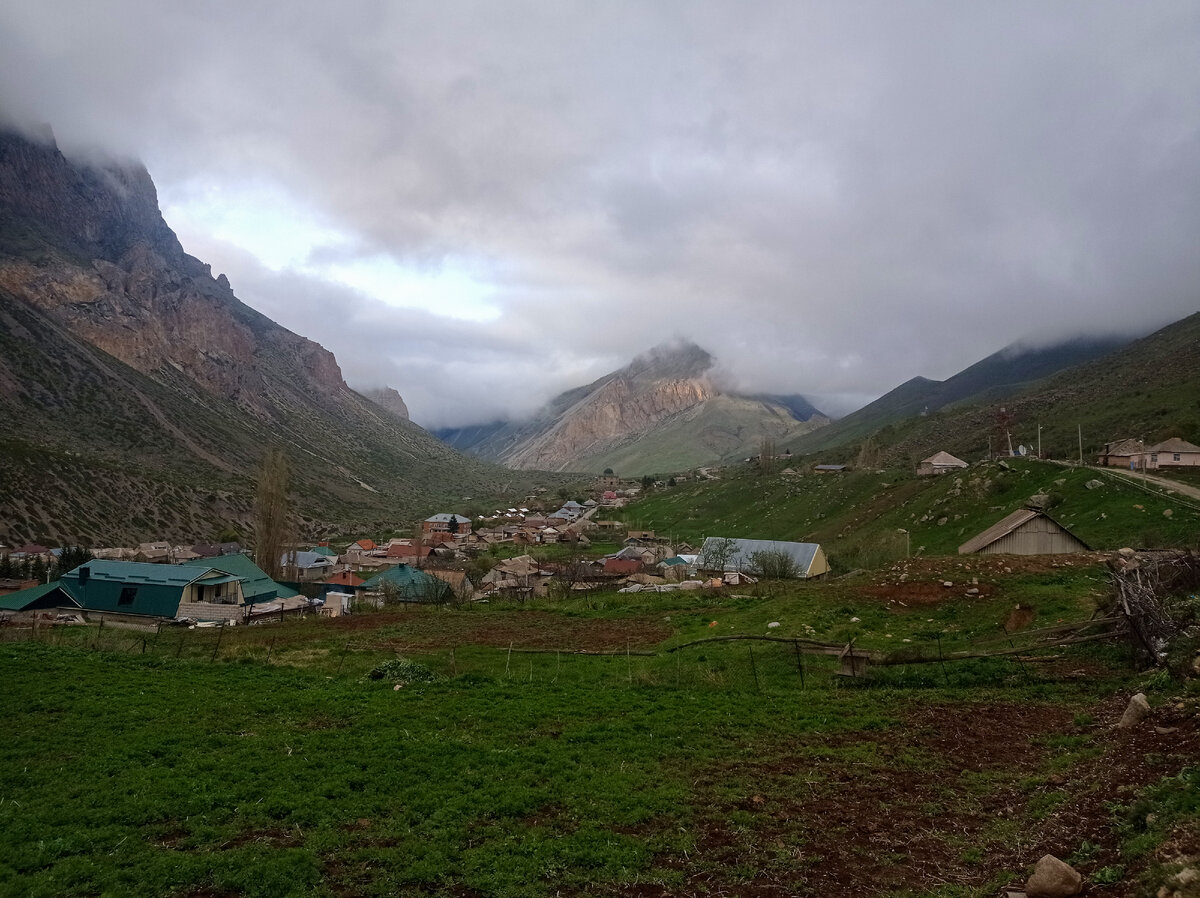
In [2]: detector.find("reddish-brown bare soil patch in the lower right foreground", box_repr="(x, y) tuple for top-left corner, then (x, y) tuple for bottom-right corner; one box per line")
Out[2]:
(624, 696), (1200, 898)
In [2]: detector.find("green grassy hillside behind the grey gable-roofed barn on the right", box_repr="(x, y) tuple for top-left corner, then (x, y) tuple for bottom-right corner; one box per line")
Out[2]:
(617, 459), (1200, 569)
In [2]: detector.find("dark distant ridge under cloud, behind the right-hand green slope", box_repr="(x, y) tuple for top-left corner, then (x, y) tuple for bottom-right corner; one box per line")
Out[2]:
(790, 336), (1130, 453)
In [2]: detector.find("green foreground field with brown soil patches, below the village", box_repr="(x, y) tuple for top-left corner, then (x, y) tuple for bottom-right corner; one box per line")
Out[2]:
(0, 558), (1200, 896)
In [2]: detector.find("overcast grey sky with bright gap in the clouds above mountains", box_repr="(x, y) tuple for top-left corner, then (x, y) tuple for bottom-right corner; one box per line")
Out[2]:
(0, 0), (1200, 427)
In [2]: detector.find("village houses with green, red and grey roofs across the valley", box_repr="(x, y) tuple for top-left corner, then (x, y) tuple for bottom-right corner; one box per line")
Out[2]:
(0, 438), (1200, 628)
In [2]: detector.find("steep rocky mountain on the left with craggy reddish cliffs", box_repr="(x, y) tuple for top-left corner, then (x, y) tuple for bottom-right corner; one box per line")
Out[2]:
(0, 133), (552, 545)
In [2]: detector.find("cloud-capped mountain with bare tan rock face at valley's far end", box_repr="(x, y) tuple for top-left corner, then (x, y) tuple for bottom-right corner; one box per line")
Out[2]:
(438, 343), (828, 474)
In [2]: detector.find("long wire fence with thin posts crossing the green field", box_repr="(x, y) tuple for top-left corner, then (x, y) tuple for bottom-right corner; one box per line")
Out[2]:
(0, 612), (1127, 693)
